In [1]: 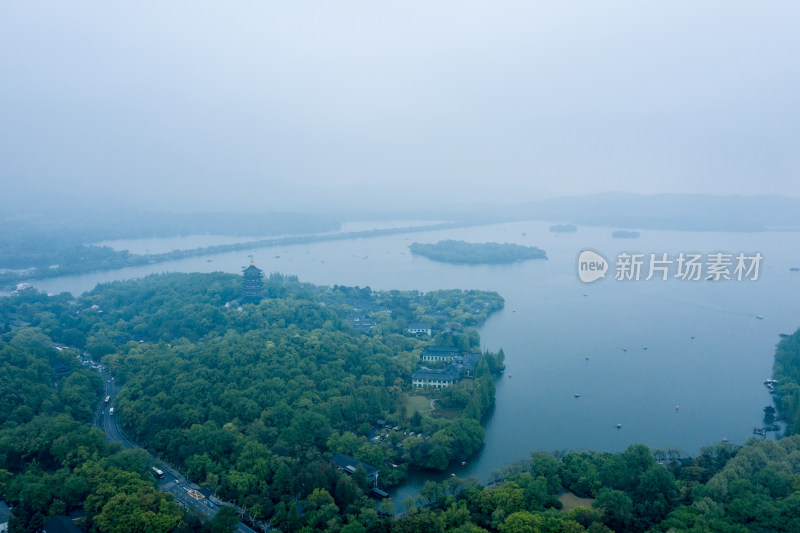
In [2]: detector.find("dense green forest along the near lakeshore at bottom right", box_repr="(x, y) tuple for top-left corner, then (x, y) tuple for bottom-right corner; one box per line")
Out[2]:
(391, 436), (800, 533)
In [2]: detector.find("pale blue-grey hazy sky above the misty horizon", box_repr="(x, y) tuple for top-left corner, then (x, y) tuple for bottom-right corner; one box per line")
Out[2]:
(0, 0), (800, 209)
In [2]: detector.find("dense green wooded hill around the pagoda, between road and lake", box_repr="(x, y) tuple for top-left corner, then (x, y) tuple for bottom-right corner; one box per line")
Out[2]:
(0, 274), (503, 528)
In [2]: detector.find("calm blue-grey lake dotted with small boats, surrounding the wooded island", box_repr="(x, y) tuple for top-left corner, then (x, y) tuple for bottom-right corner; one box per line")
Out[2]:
(28, 222), (800, 503)
